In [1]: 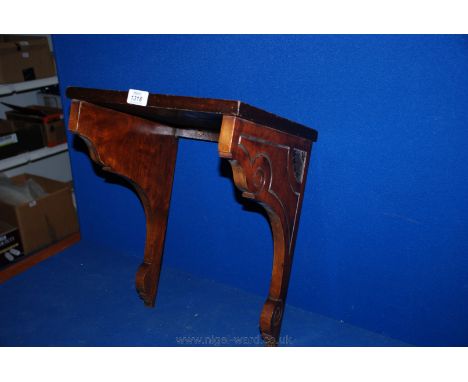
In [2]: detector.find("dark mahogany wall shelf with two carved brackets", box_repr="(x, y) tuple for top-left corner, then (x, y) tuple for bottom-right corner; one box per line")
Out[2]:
(67, 87), (317, 345)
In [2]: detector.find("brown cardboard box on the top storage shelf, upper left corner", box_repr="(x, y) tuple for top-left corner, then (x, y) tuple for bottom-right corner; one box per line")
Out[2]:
(0, 35), (56, 84)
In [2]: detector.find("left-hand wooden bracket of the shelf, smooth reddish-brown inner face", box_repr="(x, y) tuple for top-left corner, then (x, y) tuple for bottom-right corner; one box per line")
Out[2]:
(69, 101), (178, 306)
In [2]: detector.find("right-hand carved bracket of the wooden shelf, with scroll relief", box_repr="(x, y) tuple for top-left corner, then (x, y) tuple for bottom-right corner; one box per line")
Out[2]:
(219, 117), (310, 345)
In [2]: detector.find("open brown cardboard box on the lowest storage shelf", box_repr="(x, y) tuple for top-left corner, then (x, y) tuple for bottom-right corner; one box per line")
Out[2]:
(0, 174), (79, 254)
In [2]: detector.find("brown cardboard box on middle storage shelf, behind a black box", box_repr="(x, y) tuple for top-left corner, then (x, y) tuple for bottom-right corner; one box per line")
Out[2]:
(5, 104), (67, 147)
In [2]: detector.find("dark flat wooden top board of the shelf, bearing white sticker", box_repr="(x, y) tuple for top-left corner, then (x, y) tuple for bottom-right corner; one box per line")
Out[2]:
(67, 87), (317, 141)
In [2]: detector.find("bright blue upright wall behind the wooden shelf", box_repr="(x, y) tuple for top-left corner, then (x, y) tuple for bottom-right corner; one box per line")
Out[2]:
(53, 36), (468, 345)
